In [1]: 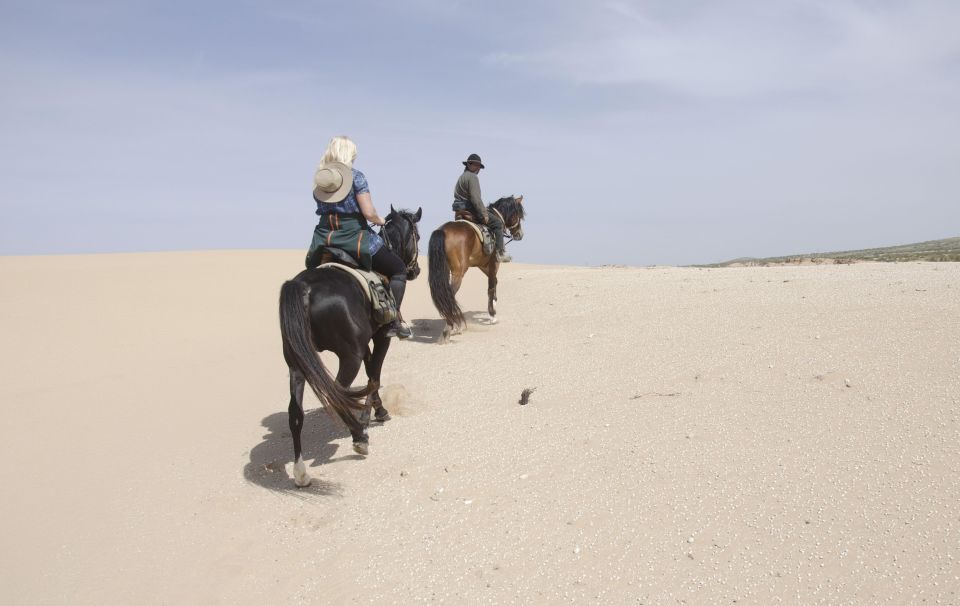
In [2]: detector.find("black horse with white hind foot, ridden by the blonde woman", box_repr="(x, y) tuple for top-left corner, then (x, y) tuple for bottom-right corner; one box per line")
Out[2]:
(280, 206), (423, 487)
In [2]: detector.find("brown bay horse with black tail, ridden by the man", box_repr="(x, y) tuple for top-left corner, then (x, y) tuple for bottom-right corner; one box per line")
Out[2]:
(428, 196), (524, 342)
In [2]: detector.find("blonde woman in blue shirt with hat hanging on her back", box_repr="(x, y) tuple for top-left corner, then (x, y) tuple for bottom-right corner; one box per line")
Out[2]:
(306, 137), (412, 339)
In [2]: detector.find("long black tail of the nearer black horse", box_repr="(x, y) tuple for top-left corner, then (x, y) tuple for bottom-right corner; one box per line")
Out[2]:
(280, 280), (370, 431)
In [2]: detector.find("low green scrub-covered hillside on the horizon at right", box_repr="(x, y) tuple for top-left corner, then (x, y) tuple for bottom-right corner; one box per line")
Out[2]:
(699, 238), (960, 267)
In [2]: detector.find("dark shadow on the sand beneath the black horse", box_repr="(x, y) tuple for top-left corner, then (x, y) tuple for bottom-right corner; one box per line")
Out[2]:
(243, 408), (363, 498)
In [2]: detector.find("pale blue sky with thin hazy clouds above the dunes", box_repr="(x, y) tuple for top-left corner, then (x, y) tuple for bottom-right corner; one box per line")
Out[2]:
(0, 0), (960, 265)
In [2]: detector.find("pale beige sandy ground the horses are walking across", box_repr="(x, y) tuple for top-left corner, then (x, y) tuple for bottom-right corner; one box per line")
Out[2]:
(0, 251), (960, 605)
